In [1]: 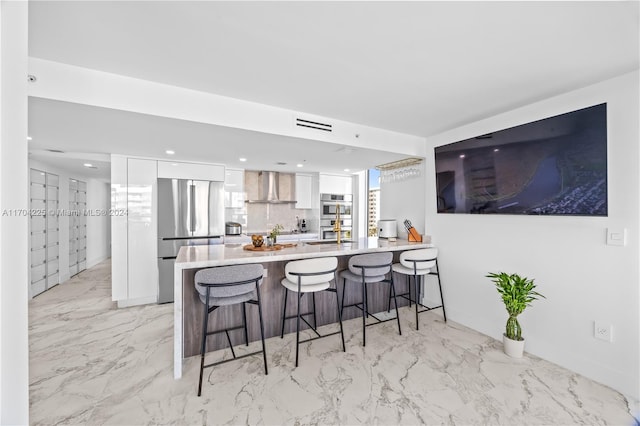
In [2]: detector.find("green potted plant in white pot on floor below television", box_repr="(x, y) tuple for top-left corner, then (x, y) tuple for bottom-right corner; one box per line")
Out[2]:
(486, 272), (544, 358)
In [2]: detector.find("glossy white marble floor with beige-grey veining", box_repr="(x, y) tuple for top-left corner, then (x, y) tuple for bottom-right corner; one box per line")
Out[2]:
(29, 261), (635, 425)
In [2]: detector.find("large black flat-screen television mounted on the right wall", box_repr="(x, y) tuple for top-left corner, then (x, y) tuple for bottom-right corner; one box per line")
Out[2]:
(435, 104), (607, 216)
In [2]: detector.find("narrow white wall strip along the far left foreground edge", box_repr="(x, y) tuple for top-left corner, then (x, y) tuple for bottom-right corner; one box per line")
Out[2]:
(0, 1), (29, 425)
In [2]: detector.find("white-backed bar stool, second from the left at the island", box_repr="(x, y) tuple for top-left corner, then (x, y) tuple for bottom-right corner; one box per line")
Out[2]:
(280, 257), (347, 367)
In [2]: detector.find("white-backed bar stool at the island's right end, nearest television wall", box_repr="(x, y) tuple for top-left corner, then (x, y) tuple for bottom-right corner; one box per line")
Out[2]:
(389, 248), (447, 330)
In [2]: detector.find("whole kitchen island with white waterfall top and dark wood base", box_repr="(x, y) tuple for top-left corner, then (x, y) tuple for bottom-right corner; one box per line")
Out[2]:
(174, 238), (431, 378)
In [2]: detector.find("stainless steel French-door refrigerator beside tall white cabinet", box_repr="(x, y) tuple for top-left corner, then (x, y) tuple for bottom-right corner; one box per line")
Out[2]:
(158, 179), (224, 303)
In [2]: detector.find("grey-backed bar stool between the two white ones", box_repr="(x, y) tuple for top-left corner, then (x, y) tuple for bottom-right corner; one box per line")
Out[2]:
(340, 252), (402, 346)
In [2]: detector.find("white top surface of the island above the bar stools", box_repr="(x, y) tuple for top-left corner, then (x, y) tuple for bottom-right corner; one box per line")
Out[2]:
(175, 237), (431, 269)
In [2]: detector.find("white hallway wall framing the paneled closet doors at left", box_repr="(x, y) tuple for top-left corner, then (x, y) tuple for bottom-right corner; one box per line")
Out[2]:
(29, 160), (111, 283)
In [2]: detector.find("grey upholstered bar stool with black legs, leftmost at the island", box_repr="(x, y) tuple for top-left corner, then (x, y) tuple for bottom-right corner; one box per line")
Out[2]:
(194, 264), (268, 396)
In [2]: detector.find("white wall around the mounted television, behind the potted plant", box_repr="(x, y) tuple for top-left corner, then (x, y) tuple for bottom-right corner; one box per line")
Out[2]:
(424, 71), (640, 400)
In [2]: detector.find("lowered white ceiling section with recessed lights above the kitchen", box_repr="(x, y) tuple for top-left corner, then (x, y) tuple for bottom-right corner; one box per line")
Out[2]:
(29, 98), (406, 180)
